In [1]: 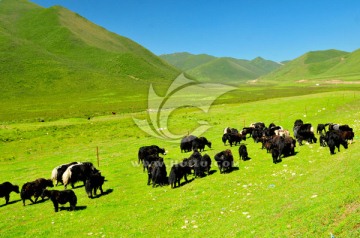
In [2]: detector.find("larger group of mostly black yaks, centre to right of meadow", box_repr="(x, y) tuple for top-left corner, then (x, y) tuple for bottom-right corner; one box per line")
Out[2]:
(138, 119), (354, 188)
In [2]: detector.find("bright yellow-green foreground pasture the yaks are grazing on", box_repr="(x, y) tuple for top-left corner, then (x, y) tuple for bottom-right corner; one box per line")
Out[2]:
(0, 91), (360, 237)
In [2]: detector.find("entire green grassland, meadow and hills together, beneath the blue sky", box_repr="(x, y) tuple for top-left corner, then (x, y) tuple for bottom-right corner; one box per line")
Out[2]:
(0, 0), (360, 237)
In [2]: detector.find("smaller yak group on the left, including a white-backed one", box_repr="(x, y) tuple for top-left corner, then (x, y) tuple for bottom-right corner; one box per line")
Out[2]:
(0, 162), (105, 212)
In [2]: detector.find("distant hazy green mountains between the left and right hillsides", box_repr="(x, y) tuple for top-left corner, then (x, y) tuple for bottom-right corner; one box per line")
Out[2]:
(160, 53), (281, 83)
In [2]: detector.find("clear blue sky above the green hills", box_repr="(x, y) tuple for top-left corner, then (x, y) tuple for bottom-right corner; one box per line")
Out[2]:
(31, 0), (360, 61)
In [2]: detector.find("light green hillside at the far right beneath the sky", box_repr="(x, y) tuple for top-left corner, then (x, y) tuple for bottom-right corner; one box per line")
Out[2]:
(260, 50), (360, 82)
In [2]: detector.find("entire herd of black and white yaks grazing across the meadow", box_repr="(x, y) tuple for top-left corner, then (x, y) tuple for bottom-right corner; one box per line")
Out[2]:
(0, 120), (354, 209)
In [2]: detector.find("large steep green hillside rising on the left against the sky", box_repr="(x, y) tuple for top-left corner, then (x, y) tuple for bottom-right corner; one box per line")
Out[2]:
(0, 0), (179, 111)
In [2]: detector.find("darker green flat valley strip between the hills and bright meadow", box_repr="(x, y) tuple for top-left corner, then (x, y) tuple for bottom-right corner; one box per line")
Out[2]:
(0, 82), (360, 124)
